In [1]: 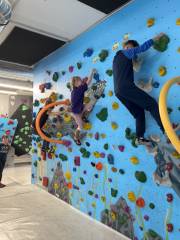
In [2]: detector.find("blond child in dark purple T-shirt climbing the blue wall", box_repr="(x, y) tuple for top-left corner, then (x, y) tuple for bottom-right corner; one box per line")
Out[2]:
(71, 69), (97, 145)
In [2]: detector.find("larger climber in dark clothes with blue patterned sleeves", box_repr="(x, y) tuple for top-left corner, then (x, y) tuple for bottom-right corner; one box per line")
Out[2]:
(113, 33), (164, 145)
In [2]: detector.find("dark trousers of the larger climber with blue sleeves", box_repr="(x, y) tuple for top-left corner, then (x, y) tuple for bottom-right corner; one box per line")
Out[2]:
(116, 85), (164, 137)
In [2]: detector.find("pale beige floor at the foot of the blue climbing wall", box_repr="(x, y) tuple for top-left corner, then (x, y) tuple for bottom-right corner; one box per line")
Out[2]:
(0, 166), (127, 240)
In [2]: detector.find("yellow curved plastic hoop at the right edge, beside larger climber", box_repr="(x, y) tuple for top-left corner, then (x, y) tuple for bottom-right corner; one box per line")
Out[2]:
(159, 76), (180, 154)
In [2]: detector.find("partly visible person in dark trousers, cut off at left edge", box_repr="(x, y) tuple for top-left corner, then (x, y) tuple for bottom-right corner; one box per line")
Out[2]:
(0, 136), (9, 188)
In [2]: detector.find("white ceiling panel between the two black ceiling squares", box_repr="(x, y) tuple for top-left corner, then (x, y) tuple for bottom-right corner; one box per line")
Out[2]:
(12, 0), (106, 40)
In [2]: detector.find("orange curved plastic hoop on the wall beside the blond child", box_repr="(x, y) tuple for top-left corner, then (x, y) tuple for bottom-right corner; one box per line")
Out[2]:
(36, 99), (70, 145)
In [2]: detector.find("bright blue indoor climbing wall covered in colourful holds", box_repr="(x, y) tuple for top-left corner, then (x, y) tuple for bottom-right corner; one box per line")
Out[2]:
(32, 0), (180, 240)
